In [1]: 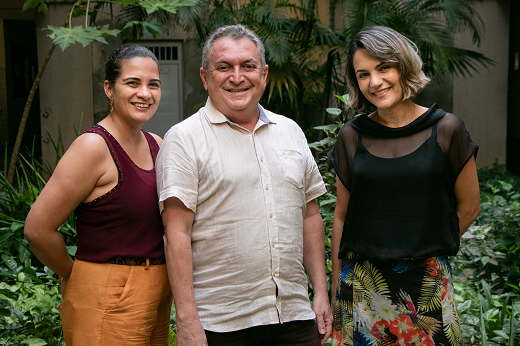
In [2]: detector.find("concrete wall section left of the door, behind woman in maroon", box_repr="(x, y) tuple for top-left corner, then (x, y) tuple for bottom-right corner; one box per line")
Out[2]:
(36, 3), (94, 163)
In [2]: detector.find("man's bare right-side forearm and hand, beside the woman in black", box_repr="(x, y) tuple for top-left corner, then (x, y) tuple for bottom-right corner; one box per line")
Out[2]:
(303, 200), (332, 345)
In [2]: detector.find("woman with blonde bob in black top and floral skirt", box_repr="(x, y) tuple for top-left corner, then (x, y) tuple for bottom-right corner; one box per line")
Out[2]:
(329, 26), (480, 346)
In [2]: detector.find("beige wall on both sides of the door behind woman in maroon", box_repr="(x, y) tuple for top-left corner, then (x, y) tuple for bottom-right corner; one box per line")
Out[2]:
(34, 0), (207, 166)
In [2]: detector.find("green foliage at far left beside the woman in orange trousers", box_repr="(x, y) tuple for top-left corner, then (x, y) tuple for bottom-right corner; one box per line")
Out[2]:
(0, 162), (65, 345)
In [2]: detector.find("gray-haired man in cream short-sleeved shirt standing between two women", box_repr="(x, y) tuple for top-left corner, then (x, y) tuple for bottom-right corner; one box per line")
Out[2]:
(156, 25), (332, 346)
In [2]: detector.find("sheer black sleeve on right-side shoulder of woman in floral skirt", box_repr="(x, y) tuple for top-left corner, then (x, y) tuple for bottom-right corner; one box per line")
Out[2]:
(438, 113), (478, 184)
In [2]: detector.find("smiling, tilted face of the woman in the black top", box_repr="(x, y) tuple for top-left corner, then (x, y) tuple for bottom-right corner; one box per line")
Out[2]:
(353, 48), (403, 111)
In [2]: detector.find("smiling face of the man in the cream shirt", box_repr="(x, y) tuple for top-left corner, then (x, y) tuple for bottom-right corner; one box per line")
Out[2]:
(200, 37), (268, 120)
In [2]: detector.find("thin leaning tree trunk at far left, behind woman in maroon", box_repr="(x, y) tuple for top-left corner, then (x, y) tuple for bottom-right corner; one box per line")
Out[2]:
(7, 0), (83, 184)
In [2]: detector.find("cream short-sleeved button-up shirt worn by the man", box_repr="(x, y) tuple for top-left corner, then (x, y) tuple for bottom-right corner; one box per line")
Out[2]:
(156, 99), (326, 332)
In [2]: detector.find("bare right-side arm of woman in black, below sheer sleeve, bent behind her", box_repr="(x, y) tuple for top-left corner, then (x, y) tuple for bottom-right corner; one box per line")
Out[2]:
(454, 157), (480, 236)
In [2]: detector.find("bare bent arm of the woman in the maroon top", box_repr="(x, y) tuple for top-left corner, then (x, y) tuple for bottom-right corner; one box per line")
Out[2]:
(24, 134), (117, 280)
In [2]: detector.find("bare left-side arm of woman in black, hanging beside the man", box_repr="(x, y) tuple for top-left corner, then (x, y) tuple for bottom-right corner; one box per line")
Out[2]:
(331, 177), (350, 309)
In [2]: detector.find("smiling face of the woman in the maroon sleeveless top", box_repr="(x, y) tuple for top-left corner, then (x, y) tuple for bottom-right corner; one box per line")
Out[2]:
(104, 58), (161, 123)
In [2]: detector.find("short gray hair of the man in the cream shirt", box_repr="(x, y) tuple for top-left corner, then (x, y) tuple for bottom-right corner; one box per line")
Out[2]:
(202, 24), (265, 71)
